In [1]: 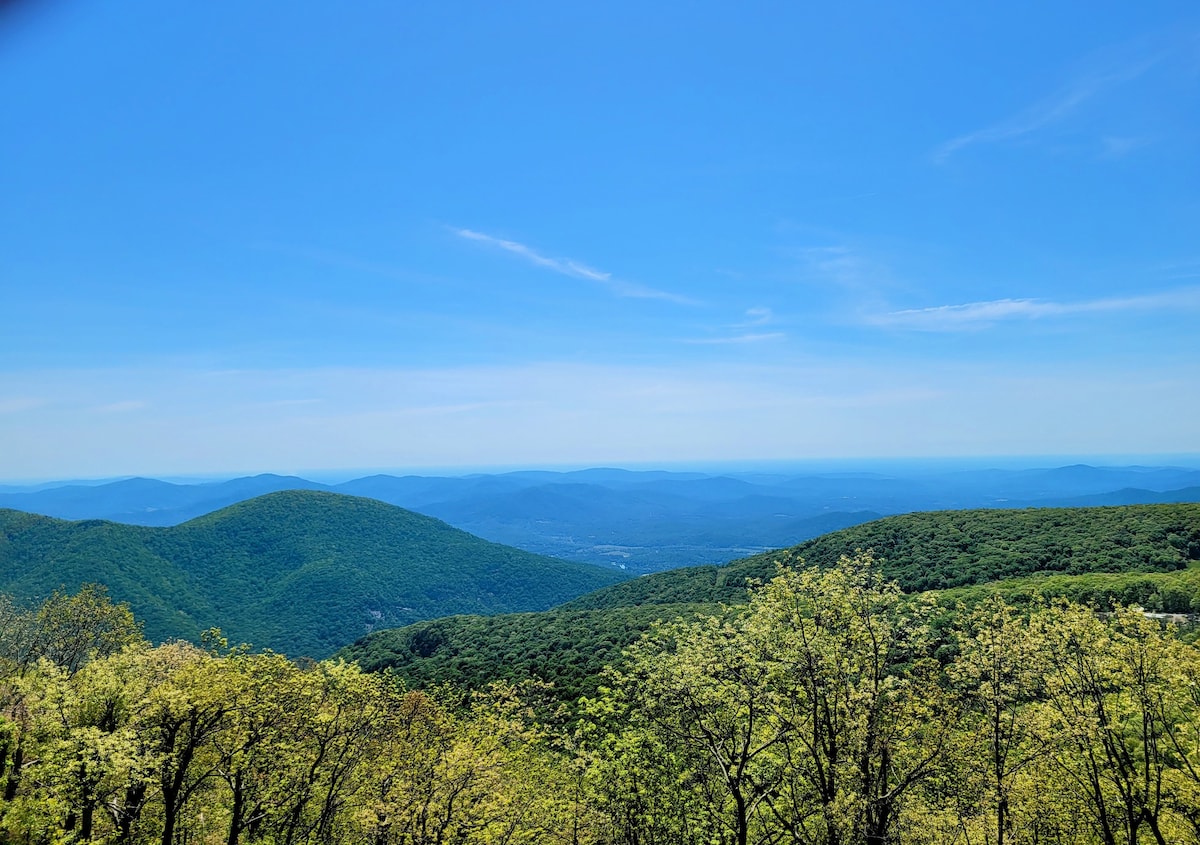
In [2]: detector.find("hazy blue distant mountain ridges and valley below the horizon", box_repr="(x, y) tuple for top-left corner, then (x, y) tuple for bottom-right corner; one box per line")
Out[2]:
(0, 465), (1200, 573)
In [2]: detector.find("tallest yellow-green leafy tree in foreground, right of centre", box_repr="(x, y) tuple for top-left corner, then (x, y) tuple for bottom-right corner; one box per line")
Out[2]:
(590, 555), (956, 845)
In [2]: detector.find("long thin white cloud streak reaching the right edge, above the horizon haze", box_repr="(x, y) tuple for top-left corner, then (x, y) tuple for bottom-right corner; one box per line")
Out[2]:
(868, 288), (1200, 331)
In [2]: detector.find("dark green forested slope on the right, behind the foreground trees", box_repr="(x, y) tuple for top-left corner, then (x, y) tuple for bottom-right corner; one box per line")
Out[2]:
(341, 504), (1200, 699)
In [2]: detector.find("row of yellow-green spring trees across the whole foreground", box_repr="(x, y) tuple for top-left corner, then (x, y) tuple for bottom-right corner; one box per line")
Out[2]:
(0, 555), (1200, 845)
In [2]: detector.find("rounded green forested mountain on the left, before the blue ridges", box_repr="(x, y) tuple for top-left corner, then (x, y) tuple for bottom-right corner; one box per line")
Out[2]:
(0, 491), (624, 657)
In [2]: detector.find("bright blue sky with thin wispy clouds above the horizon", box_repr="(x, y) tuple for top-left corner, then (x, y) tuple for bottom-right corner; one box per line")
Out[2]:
(0, 0), (1200, 479)
